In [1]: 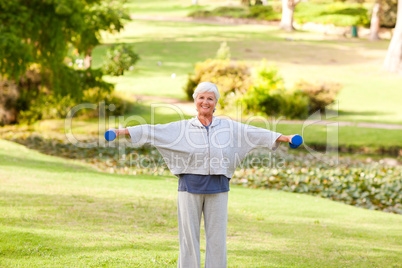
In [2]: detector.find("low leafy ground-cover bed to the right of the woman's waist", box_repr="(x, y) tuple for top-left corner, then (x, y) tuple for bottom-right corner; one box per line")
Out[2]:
(231, 154), (402, 214)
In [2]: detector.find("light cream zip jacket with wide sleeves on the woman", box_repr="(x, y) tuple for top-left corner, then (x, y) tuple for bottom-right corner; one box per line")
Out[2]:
(128, 117), (282, 178)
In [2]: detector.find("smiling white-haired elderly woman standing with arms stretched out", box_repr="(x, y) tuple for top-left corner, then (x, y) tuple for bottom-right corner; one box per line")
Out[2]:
(112, 82), (293, 268)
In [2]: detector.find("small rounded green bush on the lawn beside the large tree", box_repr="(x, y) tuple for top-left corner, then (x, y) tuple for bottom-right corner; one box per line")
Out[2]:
(103, 44), (140, 76)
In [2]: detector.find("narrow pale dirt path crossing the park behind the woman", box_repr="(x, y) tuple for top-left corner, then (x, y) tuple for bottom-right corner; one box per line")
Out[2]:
(135, 95), (402, 129)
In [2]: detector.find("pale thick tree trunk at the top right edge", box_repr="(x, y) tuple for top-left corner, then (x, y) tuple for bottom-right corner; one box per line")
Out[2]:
(384, 0), (402, 73)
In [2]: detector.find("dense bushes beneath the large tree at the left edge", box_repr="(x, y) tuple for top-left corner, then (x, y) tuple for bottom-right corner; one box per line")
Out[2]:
(0, 66), (126, 124)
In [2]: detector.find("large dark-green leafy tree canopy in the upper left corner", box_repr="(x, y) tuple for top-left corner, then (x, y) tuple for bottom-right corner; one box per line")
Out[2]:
(0, 0), (128, 92)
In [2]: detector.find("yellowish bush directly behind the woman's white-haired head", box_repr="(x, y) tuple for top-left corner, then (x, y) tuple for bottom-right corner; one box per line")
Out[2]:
(184, 59), (251, 108)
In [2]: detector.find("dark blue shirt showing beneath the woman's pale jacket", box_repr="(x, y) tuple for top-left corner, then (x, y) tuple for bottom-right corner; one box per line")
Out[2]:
(178, 122), (230, 194)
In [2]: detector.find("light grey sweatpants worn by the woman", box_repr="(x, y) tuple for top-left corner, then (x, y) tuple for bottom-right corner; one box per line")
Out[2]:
(177, 191), (229, 268)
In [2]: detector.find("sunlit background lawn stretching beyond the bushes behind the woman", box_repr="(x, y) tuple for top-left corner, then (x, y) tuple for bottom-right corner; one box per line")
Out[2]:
(93, 1), (402, 124)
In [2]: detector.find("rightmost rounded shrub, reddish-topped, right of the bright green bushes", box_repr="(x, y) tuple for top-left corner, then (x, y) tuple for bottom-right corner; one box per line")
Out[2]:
(295, 80), (342, 113)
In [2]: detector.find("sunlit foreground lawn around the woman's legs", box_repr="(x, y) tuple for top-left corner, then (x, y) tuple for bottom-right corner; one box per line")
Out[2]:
(0, 140), (402, 267)
